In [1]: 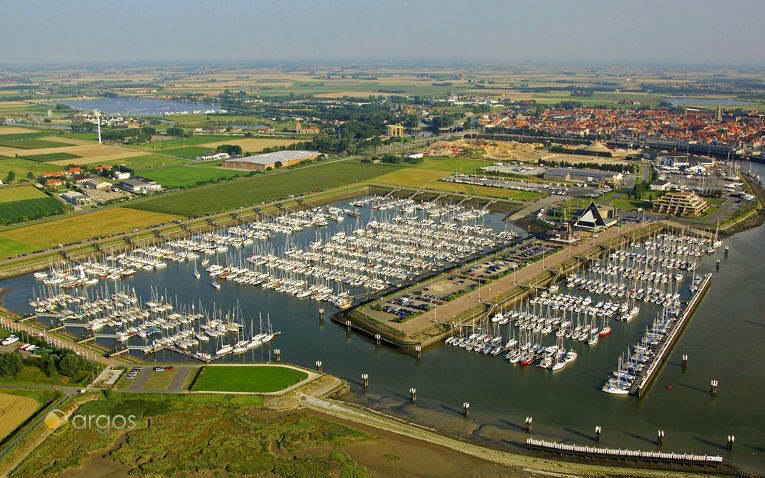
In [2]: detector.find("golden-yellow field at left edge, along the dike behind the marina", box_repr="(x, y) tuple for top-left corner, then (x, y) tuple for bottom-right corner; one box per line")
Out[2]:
(0, 208), (178, 257)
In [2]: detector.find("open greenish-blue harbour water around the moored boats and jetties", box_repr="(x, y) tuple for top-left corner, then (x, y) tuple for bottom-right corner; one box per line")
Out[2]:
(0, 181), (765, 472)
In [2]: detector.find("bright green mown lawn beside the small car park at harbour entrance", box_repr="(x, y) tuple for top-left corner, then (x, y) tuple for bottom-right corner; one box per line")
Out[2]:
(192, 365), (308, 393)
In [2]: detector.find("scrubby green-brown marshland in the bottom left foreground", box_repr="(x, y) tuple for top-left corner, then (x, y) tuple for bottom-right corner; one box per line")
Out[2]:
(10, 393), (371, 478)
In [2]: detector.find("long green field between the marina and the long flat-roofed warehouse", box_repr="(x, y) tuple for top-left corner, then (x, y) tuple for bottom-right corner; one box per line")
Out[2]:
(131, 161), (399, 216)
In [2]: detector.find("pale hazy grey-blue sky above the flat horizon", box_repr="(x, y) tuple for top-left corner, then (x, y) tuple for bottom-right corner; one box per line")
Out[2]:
(0, 0), (765, 65)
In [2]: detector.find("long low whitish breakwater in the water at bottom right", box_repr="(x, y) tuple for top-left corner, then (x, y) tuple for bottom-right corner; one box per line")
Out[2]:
(526, 438), (723, 466)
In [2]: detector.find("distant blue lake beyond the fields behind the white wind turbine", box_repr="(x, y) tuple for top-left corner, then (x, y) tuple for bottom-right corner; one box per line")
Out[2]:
(53, 98), (221, 116)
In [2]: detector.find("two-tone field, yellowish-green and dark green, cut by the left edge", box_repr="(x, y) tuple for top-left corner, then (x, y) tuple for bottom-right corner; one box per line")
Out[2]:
(0, 186), (66, 225)
